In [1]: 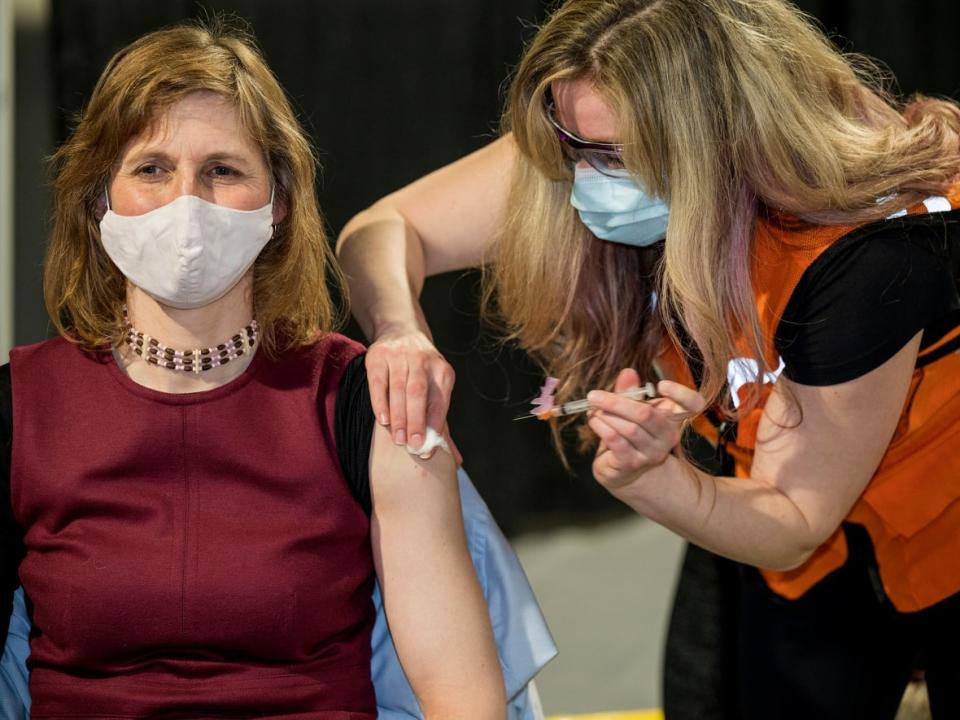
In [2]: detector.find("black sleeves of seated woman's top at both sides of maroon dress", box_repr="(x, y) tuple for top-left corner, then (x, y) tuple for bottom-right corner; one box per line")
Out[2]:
(0, 355), (374, 653)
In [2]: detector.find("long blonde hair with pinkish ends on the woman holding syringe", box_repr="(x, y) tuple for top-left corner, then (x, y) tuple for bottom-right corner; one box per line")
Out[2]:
(486, 0), (960, 434)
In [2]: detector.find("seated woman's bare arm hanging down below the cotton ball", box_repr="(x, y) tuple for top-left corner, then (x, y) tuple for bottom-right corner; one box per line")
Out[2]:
(370, 426), (506, 719)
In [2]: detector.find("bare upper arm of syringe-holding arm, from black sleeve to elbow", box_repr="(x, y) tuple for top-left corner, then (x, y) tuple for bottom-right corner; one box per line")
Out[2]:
(750, 332), (923, 549)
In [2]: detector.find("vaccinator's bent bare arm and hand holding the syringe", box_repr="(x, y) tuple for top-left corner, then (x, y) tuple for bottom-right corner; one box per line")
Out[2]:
(589, 333), (922, 570)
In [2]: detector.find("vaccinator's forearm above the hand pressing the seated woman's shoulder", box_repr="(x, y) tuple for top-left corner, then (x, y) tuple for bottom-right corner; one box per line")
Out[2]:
(337, 205), (430, 340)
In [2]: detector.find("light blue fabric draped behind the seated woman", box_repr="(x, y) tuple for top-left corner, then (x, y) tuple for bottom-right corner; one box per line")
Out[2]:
(0, 469), (557, 720)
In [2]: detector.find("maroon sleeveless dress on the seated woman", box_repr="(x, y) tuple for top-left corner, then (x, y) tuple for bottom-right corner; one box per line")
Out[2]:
(10, 335), (376, 720)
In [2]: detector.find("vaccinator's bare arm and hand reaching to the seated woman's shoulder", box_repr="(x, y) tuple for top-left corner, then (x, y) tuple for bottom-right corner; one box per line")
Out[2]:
(337, 135), (517, 446)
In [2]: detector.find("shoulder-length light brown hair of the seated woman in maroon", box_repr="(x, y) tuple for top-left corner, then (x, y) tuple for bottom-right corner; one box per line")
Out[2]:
(44, 18), (343, 353)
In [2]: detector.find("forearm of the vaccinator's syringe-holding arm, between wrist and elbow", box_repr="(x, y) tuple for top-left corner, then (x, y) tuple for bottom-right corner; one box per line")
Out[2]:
(611, 456), (826, 570)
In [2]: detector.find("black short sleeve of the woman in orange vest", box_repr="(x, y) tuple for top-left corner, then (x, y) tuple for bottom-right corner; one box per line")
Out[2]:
(775, 210), (960, 385)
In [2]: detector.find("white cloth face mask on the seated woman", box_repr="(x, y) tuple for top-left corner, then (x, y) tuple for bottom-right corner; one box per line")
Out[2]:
(100, 193), (273, 309)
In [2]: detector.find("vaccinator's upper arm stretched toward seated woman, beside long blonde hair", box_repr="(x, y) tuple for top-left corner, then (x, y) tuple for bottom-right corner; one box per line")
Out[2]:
(339, 135), (517, 275)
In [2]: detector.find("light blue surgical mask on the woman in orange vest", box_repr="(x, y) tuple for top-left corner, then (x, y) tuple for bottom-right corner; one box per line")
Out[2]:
(570, 167), (669, 247)
